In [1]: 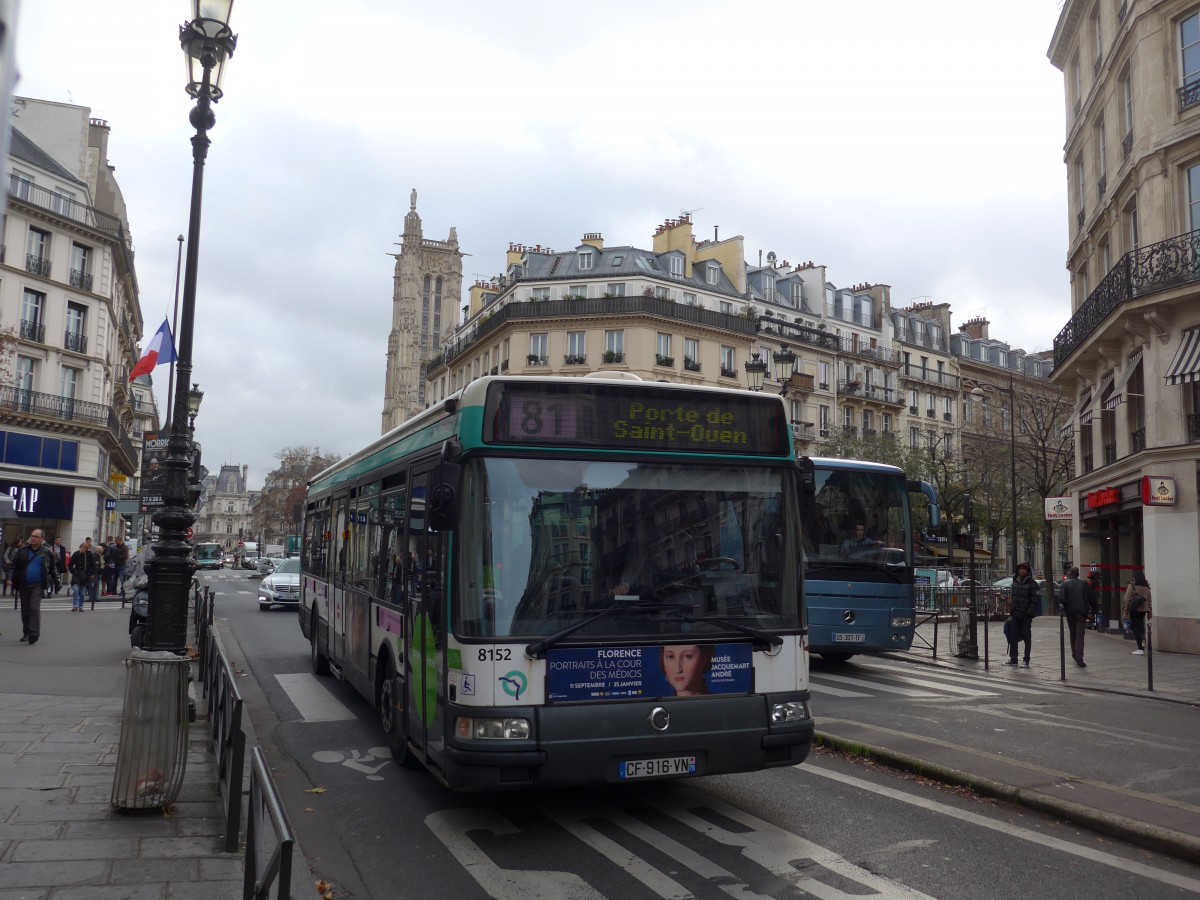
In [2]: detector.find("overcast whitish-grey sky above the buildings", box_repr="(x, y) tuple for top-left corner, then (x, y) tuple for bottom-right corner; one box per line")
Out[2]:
(16, 0), (1070, 488)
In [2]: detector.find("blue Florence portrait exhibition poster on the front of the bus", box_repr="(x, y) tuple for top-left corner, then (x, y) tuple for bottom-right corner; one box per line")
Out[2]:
(546, 643), (754, 703)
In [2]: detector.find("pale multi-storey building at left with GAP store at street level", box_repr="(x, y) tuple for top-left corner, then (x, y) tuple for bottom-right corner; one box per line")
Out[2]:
(0, 97), (144, 547)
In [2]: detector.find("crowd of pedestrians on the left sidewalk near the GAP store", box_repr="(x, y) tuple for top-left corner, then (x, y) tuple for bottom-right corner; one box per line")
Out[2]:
(4, 528), (130, 644)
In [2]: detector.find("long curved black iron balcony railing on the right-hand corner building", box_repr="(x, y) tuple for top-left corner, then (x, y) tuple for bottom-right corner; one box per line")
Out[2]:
(1054, 230), (1200, 368)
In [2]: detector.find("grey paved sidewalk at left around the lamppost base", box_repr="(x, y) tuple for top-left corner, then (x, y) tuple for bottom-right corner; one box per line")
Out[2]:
(0, 595), (244, 900)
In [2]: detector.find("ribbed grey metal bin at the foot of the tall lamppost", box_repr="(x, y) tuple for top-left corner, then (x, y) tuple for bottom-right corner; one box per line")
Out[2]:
(112, 650), (190, 811)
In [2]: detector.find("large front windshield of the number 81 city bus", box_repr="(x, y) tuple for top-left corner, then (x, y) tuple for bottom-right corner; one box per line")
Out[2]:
(455, 457), (800, 642)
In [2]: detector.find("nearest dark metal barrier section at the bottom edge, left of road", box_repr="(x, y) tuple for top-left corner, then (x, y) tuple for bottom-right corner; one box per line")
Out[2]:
(241, 746), (295, 900)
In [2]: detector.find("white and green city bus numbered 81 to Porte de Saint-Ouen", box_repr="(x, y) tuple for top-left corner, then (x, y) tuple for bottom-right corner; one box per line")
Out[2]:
(299, 376), (814, 791)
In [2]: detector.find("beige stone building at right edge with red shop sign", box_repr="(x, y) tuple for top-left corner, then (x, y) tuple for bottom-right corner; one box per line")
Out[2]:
(1049, 0), (1200, 653)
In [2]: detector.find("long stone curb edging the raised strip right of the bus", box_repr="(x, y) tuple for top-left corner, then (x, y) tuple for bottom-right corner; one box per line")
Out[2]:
(814, 730), (1200, 863)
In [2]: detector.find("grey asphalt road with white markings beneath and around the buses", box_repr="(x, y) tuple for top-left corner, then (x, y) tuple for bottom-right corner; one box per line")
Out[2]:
(203, 570), (1200, 900)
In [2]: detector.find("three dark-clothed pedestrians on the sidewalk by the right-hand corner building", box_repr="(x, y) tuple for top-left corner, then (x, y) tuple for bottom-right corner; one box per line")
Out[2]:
(1004, 563), (1152, 668)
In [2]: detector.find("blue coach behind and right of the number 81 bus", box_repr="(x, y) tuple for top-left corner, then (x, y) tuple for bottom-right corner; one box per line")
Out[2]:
(802, 457), (940, 661)
